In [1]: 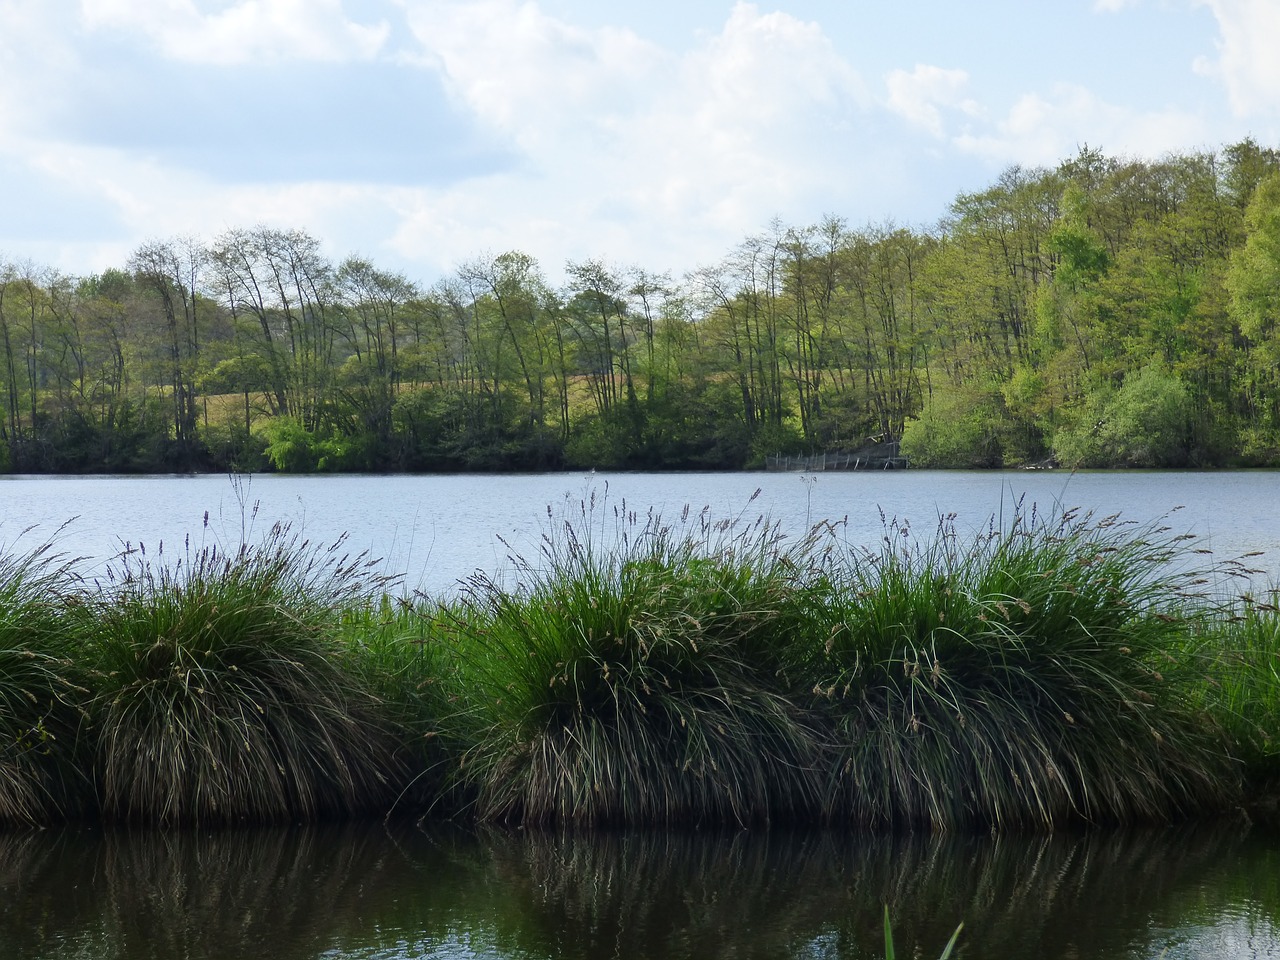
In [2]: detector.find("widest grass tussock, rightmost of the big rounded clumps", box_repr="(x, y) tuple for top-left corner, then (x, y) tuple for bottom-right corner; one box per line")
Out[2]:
(805, 508), (1238, 829)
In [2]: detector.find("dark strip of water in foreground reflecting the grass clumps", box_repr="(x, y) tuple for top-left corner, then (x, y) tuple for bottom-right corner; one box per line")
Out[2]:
(0, 826), (1280, 960)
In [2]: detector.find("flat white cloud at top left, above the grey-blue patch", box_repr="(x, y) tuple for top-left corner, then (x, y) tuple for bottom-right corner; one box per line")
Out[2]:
(81, 0), (389, 65)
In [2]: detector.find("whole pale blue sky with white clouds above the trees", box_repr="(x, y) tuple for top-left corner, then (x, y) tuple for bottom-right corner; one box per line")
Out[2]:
(0, 0), (1280, 285)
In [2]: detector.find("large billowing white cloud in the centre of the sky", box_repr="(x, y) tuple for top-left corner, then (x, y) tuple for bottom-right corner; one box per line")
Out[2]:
(396, 0), (868, 268)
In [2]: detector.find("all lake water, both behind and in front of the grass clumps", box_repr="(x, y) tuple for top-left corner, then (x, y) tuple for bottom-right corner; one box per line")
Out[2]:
(0, 471), (1280, 960)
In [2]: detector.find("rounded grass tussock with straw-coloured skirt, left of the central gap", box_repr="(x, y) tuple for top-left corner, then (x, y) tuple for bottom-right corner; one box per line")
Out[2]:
(84, 525), (397, 824)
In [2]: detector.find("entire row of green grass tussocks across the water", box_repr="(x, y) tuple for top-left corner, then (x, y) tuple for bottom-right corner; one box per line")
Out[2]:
(0, 504), (1280, 829)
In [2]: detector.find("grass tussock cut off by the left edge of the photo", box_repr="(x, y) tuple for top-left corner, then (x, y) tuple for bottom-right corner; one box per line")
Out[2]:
(0, 543), (87, 826)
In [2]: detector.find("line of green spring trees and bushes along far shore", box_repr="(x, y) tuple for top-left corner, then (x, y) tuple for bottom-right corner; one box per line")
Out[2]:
(0, 140), (1280, 472)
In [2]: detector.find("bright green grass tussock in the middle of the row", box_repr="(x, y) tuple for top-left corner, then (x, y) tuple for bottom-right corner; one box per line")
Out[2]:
(461, 504), (819, 824)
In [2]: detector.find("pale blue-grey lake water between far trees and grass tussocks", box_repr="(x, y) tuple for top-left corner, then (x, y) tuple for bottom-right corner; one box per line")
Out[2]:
(0, 470), (1280, 594)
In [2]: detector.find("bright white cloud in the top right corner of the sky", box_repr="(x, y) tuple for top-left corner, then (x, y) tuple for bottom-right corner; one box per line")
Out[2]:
(1196, 0), (1280, 118)
